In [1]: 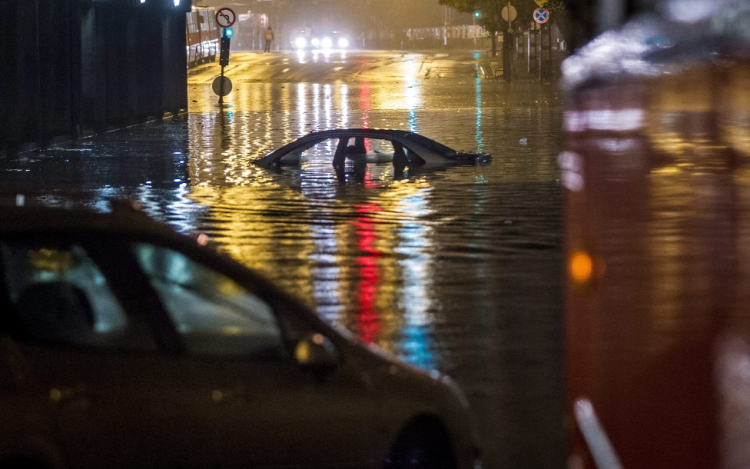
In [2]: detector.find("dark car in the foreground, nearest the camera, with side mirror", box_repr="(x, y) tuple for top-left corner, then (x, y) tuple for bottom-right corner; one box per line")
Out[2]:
(0, 201), (479, 468)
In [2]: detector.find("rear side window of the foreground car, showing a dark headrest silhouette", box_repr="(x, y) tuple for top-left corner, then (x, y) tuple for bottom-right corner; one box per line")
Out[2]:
(0, 240), (157, 350)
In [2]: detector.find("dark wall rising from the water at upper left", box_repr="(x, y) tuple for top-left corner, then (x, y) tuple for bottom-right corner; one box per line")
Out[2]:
(0, 0), (190, 155)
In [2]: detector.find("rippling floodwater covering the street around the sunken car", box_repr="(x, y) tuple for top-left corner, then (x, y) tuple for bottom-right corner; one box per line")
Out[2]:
(0, 52), (565, 468)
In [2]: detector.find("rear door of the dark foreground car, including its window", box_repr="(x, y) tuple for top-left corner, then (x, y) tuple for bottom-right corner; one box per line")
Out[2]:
(0, 236), (214, 468)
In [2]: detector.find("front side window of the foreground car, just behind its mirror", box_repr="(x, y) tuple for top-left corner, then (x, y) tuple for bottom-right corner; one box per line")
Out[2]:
(133, 243), (282, 356)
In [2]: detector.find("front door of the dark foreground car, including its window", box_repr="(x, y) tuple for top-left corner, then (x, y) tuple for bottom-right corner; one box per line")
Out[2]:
(133, 243), (382, 468)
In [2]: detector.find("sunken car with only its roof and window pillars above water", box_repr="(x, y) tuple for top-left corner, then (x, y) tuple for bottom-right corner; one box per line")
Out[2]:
(255, 128), (492, 169)
